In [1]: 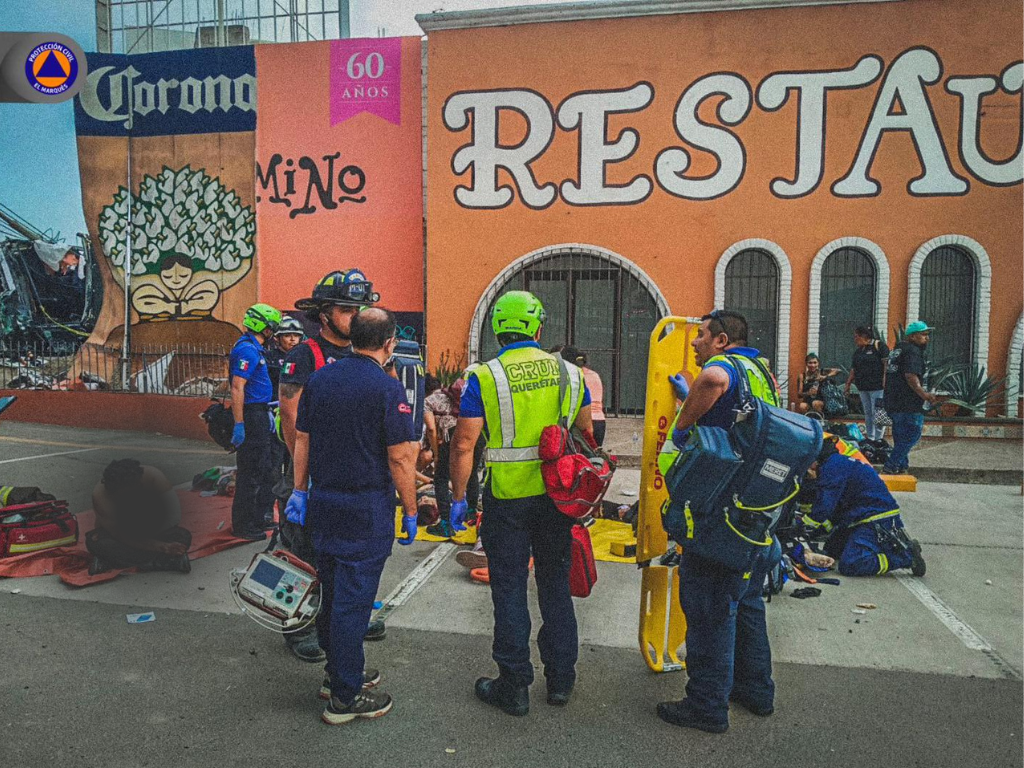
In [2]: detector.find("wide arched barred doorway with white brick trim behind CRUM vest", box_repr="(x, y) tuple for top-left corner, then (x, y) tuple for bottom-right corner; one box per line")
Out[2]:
(469, 245), (669, 414)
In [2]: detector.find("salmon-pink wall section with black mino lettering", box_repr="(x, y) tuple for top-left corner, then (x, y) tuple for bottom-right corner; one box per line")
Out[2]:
(256, 38), (423, 312)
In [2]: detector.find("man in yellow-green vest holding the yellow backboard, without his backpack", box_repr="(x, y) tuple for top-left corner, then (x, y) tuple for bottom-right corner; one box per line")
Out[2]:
(657, 309), (781, 733)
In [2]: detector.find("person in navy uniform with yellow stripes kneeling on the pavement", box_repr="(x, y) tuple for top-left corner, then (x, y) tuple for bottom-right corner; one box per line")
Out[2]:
(804, 440), (925, 577)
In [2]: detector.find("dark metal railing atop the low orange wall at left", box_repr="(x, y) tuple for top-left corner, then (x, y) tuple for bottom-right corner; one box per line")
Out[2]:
(0, 342), (229, 397)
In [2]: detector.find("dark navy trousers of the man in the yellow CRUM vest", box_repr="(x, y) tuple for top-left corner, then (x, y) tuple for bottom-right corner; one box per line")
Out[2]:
(480, 485), (580, 690)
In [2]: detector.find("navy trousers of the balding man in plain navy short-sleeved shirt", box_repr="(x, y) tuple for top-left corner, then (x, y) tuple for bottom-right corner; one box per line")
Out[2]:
(316, 540), (391, 706)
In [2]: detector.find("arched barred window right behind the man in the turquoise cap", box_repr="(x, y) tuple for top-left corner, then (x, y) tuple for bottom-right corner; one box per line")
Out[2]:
(918, 245), (978, 365)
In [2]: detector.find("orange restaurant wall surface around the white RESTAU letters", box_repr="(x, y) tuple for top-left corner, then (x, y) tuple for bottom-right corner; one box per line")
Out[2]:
(427, 0), (1024, 387)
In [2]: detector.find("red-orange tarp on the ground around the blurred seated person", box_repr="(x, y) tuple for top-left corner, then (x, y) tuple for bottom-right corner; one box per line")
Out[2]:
(0, 490), (252, 587)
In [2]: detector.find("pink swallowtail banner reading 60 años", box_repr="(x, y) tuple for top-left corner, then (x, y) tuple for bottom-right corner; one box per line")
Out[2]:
(331, 38), (401, 125)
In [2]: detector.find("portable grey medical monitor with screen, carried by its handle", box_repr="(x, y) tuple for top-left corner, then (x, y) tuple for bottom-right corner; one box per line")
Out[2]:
(230, 550), (319, 632)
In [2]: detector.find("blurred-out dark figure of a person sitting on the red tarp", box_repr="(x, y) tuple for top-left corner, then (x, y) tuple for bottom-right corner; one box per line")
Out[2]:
(85, 459), (191, 575)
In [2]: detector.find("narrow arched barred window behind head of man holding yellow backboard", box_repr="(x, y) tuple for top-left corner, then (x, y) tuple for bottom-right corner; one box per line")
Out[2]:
(724, 248), (779, 360)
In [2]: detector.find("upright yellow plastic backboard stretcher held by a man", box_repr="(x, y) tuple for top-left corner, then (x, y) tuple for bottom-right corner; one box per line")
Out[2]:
(637, 317), (700, 672)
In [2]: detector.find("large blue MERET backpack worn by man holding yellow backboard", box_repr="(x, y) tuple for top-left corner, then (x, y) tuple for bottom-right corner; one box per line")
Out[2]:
(662, 356), (822, 571)
